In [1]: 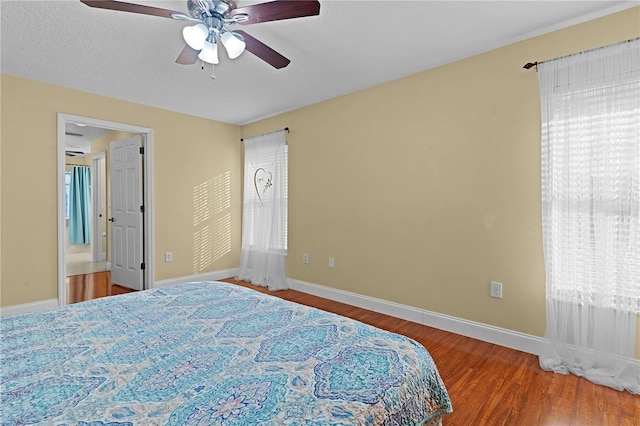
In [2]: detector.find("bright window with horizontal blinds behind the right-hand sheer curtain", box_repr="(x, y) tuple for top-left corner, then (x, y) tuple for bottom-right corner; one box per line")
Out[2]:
(543, 50), (640, 311)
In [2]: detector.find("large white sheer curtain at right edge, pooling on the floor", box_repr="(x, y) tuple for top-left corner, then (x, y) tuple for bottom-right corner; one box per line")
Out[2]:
(538, 39), (640, 393)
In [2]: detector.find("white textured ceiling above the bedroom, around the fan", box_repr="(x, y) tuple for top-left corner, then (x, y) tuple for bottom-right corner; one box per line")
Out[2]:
(0, 0), (640, 125)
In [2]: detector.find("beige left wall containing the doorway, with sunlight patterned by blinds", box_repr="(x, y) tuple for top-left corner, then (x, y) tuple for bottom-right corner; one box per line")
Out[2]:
(0, 74), (241, 306)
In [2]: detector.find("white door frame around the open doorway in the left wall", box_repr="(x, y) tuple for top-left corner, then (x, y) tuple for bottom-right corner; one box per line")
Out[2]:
(57, 112), (154, 306)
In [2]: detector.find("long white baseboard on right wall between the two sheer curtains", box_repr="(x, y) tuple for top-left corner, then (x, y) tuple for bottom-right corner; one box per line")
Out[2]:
(288, 279), (547, 355)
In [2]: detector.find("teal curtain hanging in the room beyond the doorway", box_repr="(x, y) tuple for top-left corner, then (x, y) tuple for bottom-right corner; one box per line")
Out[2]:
(69, 166), (91, 244)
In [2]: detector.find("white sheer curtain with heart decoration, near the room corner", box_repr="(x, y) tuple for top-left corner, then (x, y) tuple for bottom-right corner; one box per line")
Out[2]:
(236, 130), (289, 290)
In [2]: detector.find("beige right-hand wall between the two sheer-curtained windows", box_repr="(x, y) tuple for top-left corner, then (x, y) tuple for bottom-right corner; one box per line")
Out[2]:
(242, 8), (640, 353)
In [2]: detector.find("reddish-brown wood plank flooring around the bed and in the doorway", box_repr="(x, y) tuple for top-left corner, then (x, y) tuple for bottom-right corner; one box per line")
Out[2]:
(67, 274), (640, 426)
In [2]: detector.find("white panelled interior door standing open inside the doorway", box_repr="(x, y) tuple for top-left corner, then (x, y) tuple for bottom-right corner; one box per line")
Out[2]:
(109, 135), (144, 290)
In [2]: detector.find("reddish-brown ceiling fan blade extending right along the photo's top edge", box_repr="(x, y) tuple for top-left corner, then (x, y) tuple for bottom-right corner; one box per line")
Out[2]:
(229, 0), (320, 25)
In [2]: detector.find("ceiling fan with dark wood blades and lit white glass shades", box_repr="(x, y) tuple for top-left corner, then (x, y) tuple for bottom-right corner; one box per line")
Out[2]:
(80, 0), (320, 70)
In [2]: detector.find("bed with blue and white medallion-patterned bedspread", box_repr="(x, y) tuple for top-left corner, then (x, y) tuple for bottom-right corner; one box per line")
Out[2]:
(0, 282), (452, 426)
